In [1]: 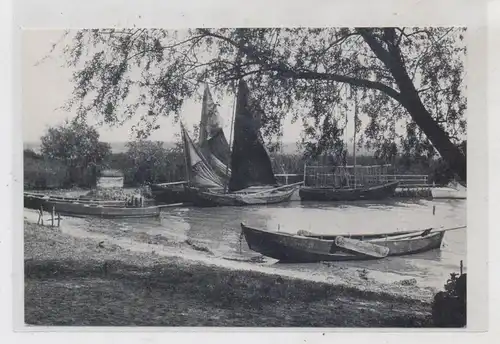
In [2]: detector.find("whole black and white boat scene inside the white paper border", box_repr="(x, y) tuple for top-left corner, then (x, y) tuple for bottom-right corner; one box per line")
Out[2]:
(21, 26), (468, 328)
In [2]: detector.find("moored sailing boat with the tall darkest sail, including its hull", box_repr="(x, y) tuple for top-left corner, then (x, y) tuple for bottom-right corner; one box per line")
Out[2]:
(187, 80), (302, 206)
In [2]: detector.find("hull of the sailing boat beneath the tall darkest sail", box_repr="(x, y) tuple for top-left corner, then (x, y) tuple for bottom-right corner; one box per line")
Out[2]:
(187, 187), (297, 207)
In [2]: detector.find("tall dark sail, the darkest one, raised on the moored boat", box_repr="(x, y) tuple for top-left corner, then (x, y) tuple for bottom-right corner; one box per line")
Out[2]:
(229, 80), (277, 191)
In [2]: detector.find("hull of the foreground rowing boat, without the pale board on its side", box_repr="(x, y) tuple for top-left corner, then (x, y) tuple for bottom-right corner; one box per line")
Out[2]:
(241, 224), (444, 263)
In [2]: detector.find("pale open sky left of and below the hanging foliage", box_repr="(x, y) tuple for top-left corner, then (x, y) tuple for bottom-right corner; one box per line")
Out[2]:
(22, 30), (324, 142)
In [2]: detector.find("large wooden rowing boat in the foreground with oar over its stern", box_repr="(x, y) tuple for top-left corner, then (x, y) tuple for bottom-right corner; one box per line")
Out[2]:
(241, 223), (465, 263)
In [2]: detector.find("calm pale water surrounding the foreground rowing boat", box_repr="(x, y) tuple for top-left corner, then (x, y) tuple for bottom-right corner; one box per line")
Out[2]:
(26, 200), (466, 288)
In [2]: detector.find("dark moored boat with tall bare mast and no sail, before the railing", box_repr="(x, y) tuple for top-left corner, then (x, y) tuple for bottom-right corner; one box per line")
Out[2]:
(299, 90), (399, 201)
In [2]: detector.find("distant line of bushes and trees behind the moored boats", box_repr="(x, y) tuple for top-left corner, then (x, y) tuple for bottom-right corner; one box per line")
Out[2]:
(24, 120), (465, 189)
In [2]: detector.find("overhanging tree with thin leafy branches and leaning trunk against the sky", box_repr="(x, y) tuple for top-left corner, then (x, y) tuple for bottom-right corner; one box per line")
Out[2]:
(52, 28), (466, 179)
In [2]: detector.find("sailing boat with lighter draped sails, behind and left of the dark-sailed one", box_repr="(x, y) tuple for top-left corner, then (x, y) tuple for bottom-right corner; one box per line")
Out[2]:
(151, 85), (231, 203)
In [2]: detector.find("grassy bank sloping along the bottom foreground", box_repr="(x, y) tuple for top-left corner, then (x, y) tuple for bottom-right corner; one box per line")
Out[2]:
(24, 223), (431, 327)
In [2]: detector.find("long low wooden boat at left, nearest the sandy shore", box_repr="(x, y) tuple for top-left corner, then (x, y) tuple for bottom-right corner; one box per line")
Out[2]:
(45, 202), (162, 218)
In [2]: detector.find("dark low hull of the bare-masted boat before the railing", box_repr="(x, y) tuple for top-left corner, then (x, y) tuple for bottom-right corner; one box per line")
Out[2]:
(299, 181), (399, 201)
